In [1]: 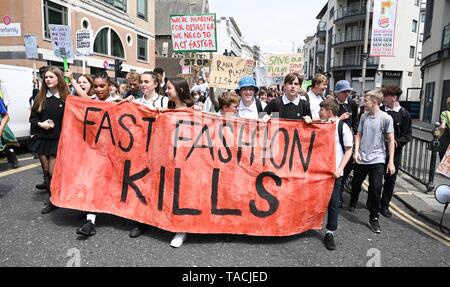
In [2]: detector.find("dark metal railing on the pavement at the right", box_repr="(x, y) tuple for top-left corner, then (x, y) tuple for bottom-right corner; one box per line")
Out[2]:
(400, 125), (439, 192)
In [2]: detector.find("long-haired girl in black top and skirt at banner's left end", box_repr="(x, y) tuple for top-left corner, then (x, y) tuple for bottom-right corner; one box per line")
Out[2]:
(29, 66), (69, 214)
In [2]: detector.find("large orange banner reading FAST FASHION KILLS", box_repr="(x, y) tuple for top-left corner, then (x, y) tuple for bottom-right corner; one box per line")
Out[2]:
(51, 97), (335, 236)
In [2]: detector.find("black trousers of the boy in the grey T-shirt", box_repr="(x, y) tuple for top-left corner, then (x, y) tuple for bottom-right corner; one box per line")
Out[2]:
(350, 163), (385, 219)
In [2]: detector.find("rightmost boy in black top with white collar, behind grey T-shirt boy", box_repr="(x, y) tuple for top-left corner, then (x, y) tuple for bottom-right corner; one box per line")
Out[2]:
(380, 86), (412, 218)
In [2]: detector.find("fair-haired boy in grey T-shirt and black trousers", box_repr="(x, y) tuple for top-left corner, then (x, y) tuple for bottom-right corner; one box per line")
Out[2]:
(349, 90), (395, 233)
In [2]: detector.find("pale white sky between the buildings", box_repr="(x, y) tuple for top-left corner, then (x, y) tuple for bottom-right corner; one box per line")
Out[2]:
(209, 0), (328, 54)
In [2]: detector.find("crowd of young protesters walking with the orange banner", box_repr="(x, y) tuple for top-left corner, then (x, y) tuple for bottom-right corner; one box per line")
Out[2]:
(7, 63), (450, 250)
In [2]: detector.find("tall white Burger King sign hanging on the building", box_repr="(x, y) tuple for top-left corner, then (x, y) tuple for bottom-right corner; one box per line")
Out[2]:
(370, 0), (397, 57)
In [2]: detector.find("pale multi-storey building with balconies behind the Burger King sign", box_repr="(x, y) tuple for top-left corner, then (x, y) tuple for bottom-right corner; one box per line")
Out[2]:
(305, 0), (421, 111)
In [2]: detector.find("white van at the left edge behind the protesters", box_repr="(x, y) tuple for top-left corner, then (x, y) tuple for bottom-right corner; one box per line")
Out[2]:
(0, 65), (33, 142)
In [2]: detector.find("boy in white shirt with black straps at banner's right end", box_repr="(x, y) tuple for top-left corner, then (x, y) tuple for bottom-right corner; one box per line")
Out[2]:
(319, 98), (353, 250)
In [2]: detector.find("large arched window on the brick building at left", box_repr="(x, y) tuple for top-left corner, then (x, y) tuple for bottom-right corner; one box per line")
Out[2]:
(94, 28), (125, 59)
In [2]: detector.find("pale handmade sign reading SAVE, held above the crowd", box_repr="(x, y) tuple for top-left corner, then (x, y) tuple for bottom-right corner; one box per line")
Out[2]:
(267, 54), (303, 78)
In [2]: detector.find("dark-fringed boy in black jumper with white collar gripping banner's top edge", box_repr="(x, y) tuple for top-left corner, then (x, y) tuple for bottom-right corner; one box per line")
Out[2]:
(263, 73), (311, 123)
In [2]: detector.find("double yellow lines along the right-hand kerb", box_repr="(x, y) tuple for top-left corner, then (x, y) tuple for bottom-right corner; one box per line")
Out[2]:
(362, 181), (450, 247)
